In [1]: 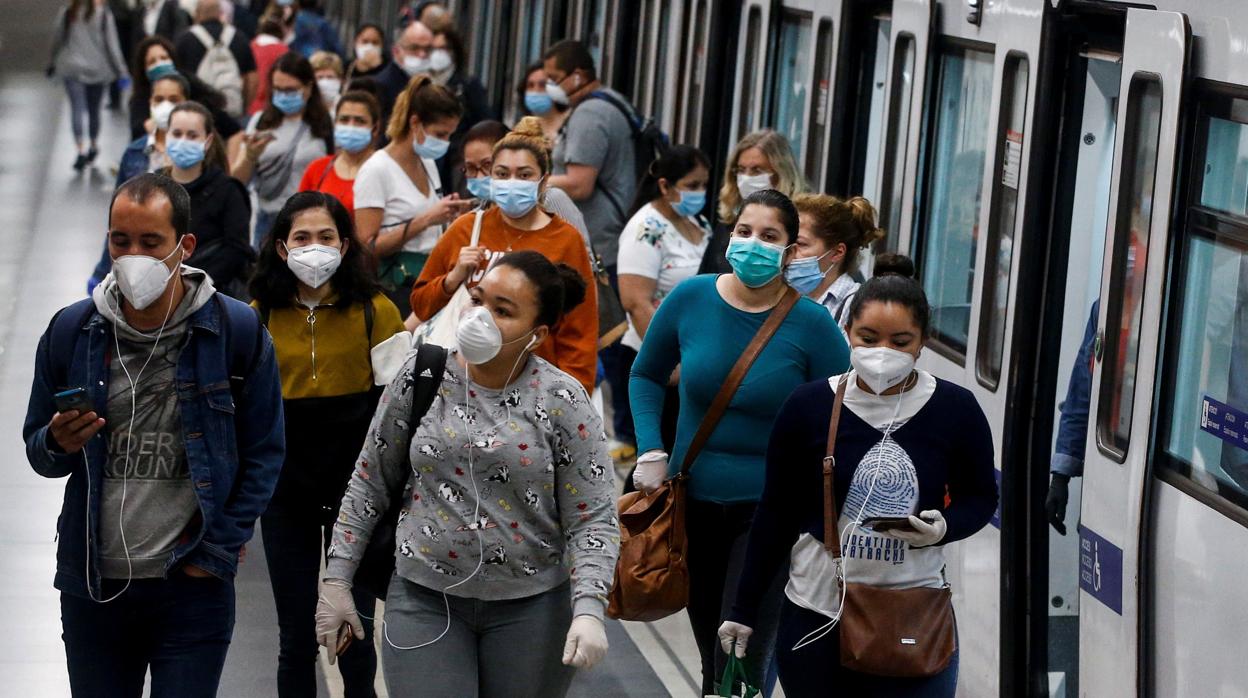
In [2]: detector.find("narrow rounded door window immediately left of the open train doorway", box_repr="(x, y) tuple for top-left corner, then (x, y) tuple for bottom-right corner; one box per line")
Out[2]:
(977, 56), (1027, 390)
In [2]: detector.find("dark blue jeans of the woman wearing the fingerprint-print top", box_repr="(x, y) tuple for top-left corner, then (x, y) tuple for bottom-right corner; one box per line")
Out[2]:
(776, 598), (957, 698)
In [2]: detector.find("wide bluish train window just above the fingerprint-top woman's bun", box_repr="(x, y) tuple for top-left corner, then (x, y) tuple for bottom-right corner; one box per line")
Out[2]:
(915, 46), (992, 361)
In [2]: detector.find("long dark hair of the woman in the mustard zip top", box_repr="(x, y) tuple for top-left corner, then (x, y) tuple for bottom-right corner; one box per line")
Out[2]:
(247, 191), (381, 308)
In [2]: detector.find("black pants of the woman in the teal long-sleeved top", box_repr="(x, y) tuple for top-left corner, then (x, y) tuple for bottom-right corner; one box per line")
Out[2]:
(685, 497), (789, 696)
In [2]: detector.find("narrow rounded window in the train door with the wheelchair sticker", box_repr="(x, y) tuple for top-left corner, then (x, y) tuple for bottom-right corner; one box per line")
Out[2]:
(1097, 75), (1162, 462)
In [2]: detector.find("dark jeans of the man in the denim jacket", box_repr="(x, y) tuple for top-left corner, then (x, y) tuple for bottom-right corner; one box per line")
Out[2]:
(61, 571), (235, 698)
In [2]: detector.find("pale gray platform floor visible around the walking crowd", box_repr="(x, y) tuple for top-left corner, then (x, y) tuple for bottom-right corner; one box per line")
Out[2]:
(0, 0), (699, 698)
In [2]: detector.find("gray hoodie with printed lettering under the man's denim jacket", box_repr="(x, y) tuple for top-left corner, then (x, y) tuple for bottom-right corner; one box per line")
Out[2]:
(91, 266), (216, 579)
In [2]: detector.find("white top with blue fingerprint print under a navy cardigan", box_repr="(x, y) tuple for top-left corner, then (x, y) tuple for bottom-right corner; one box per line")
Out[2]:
(785, 371), (945, 618)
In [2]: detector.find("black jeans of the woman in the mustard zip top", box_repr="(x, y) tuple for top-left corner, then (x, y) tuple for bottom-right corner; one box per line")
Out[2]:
(260, 488), (377, 698)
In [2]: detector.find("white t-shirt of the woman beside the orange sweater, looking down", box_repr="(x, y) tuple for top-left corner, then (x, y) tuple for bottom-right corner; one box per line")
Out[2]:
(353, 150), (443, 255)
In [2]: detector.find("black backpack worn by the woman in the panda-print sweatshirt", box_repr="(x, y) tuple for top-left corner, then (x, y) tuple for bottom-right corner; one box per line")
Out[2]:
(352, 343), (447, 601)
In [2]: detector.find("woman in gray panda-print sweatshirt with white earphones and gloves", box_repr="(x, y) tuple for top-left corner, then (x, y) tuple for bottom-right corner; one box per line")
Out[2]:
(317, 251), (619, 697)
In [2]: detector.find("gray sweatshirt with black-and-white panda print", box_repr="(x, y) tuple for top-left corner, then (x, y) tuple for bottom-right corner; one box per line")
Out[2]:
(326, 352), (619, 618)
